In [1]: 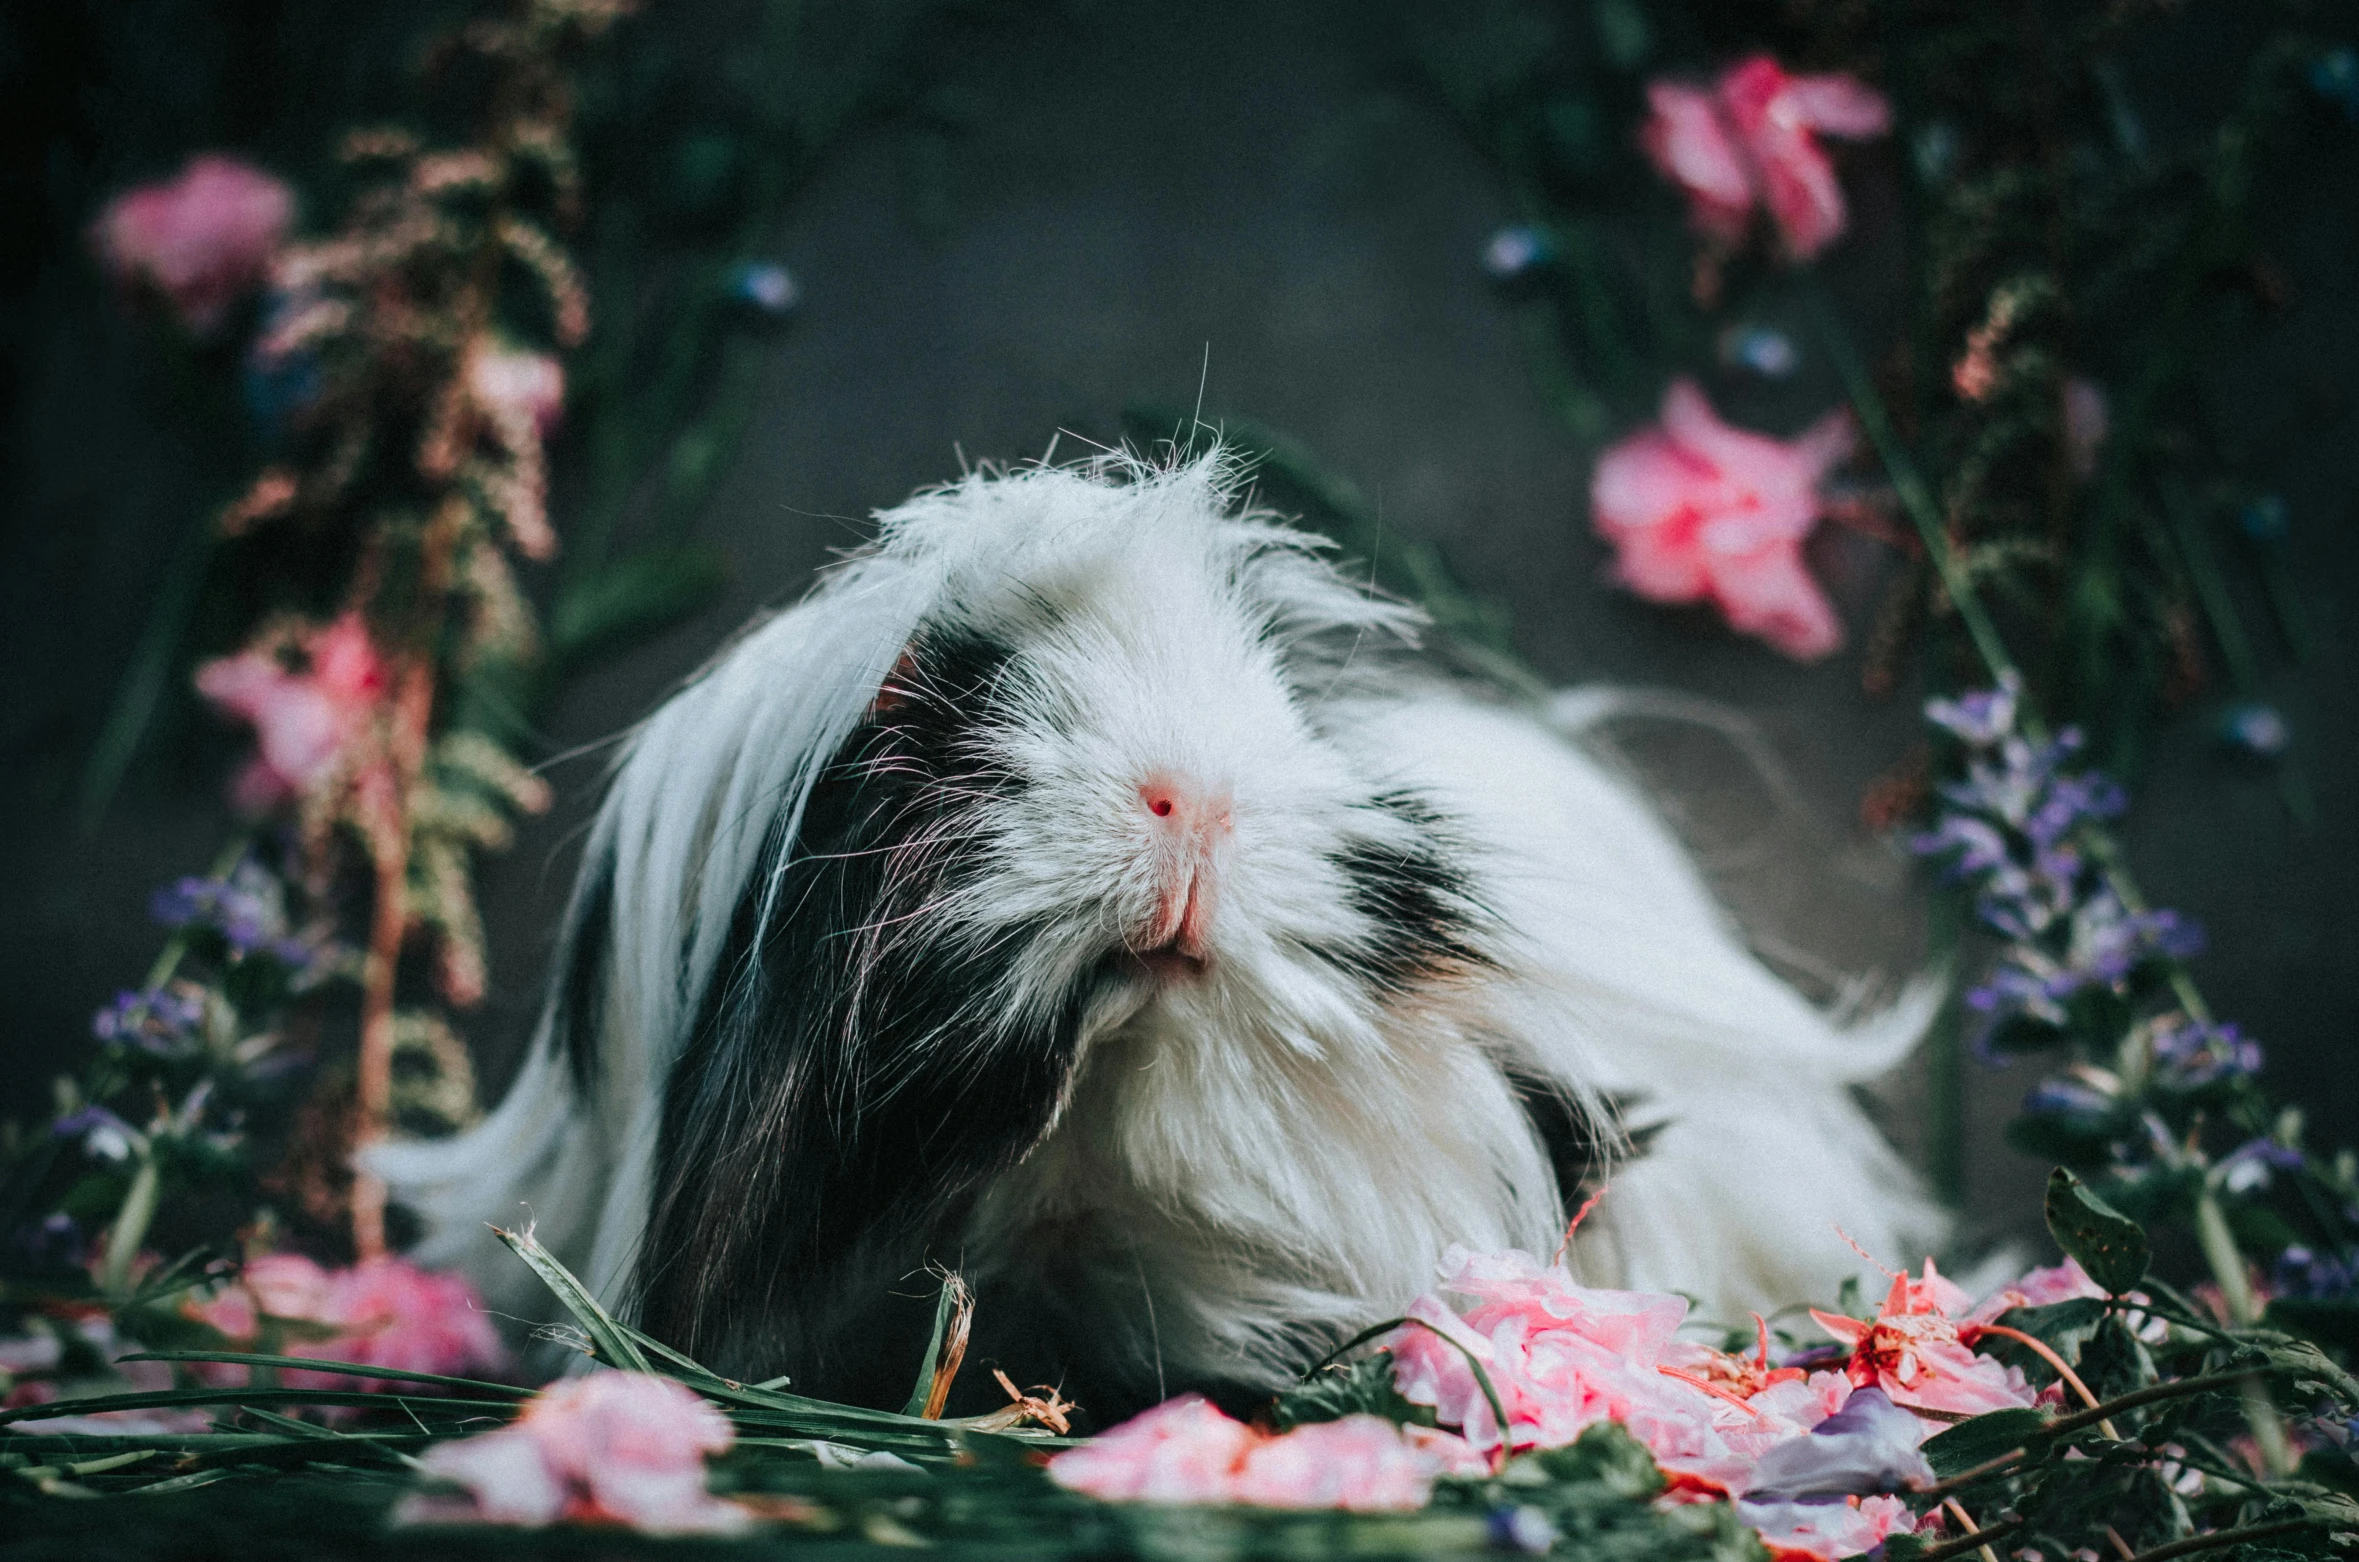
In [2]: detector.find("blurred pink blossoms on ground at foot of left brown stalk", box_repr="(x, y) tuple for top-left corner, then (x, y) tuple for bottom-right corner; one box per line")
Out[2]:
(189, 1253), (507, 1390)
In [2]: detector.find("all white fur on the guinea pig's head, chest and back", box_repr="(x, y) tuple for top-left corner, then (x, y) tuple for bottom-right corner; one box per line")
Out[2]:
(370, 460), (1941, 1378)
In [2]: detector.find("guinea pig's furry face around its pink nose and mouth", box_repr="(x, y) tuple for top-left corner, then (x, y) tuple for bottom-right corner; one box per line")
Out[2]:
(875, 523), (1474, 1052)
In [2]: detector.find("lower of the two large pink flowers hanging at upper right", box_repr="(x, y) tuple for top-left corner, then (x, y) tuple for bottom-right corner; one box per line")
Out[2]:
(1590, 380), (1852, 661)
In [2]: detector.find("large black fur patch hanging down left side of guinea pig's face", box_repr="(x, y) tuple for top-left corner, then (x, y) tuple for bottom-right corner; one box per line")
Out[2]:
(639, 637), (1095, 1402)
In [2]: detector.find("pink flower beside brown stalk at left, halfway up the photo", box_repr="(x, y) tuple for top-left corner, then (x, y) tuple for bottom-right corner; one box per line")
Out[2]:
(196, 611), (385, 814)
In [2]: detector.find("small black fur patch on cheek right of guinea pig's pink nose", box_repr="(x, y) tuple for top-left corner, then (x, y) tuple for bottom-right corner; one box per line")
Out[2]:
(1312, 790), (1491, 993)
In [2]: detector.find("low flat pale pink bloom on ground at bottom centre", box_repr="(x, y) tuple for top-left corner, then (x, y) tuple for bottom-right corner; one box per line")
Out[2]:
(1047, 1394), (1453, 1510)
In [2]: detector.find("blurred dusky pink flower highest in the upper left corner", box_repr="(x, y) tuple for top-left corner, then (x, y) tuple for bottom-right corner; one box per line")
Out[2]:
(92, 153), (295, 333)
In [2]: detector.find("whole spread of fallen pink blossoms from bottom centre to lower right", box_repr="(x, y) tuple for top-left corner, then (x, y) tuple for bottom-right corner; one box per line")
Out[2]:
(1050, 1248), (2097, 1562)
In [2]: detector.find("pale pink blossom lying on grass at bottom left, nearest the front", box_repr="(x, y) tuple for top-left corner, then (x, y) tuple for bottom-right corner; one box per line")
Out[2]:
(394, 1371), (753, 1534)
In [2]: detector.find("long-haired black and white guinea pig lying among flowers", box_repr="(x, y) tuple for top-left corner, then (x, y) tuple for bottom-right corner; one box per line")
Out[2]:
(373, 458), (1939, 1425)
